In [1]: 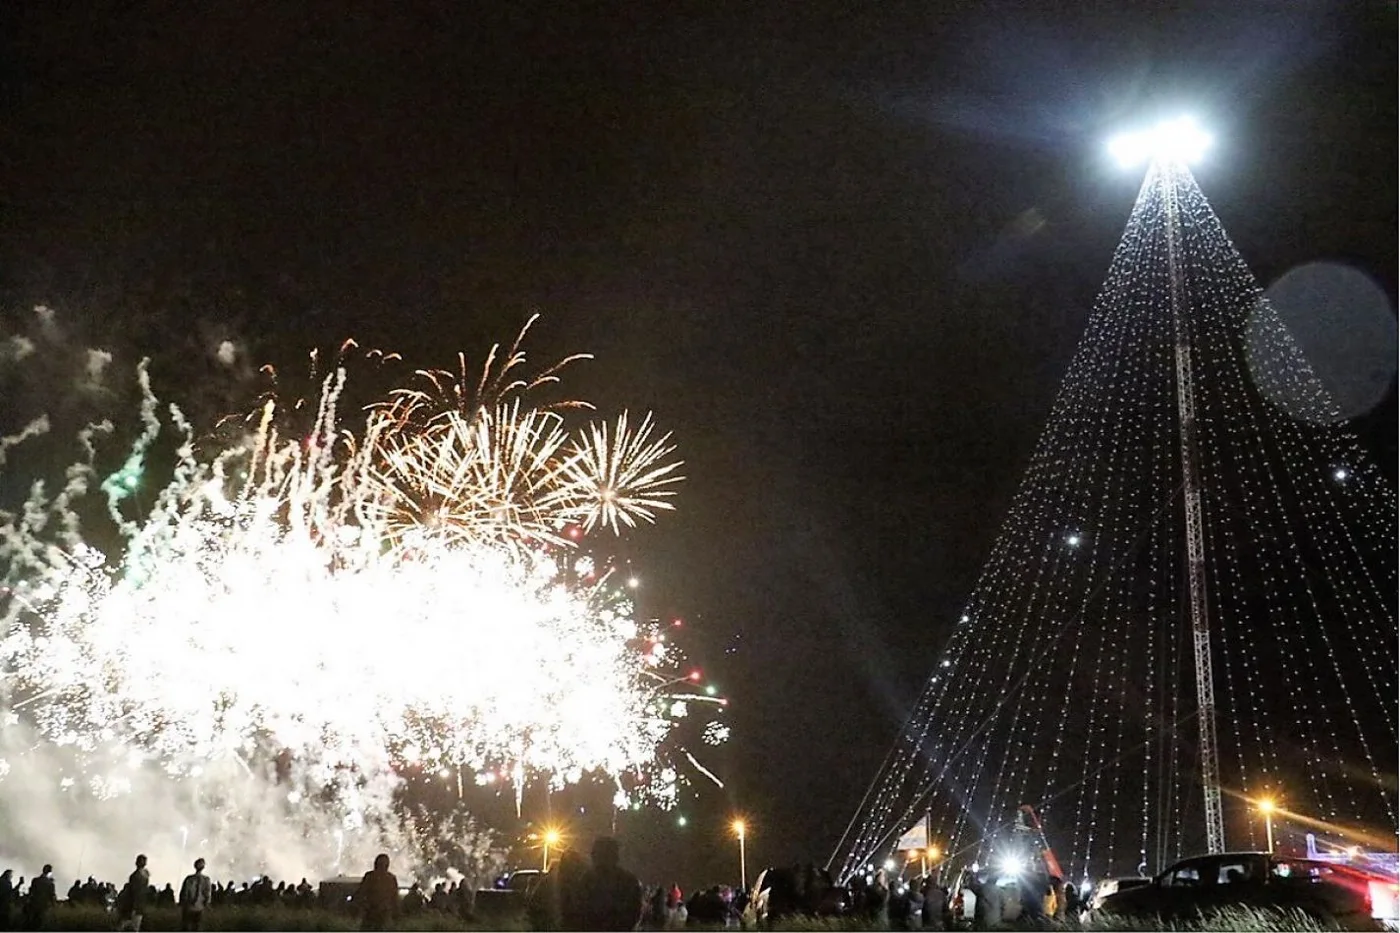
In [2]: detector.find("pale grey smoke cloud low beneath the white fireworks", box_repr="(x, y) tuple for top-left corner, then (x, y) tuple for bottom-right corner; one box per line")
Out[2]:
(0, 717), (409, 887)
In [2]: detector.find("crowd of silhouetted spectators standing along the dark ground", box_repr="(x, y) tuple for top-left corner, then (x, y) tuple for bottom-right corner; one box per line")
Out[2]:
(0, 836), (1079, 933)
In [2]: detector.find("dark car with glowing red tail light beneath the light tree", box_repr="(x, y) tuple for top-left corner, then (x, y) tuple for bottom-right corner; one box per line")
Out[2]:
(1102, 852), (1371, 922)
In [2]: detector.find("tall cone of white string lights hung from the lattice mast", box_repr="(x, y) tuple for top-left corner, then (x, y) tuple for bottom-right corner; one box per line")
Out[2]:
(833, 149), (1397, 878)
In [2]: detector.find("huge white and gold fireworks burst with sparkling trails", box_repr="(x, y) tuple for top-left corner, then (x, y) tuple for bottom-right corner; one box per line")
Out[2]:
(0, 316), (717, 874)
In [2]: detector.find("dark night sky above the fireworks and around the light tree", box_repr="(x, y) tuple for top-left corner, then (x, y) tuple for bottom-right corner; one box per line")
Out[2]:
(0, 0), (1397, 881)
